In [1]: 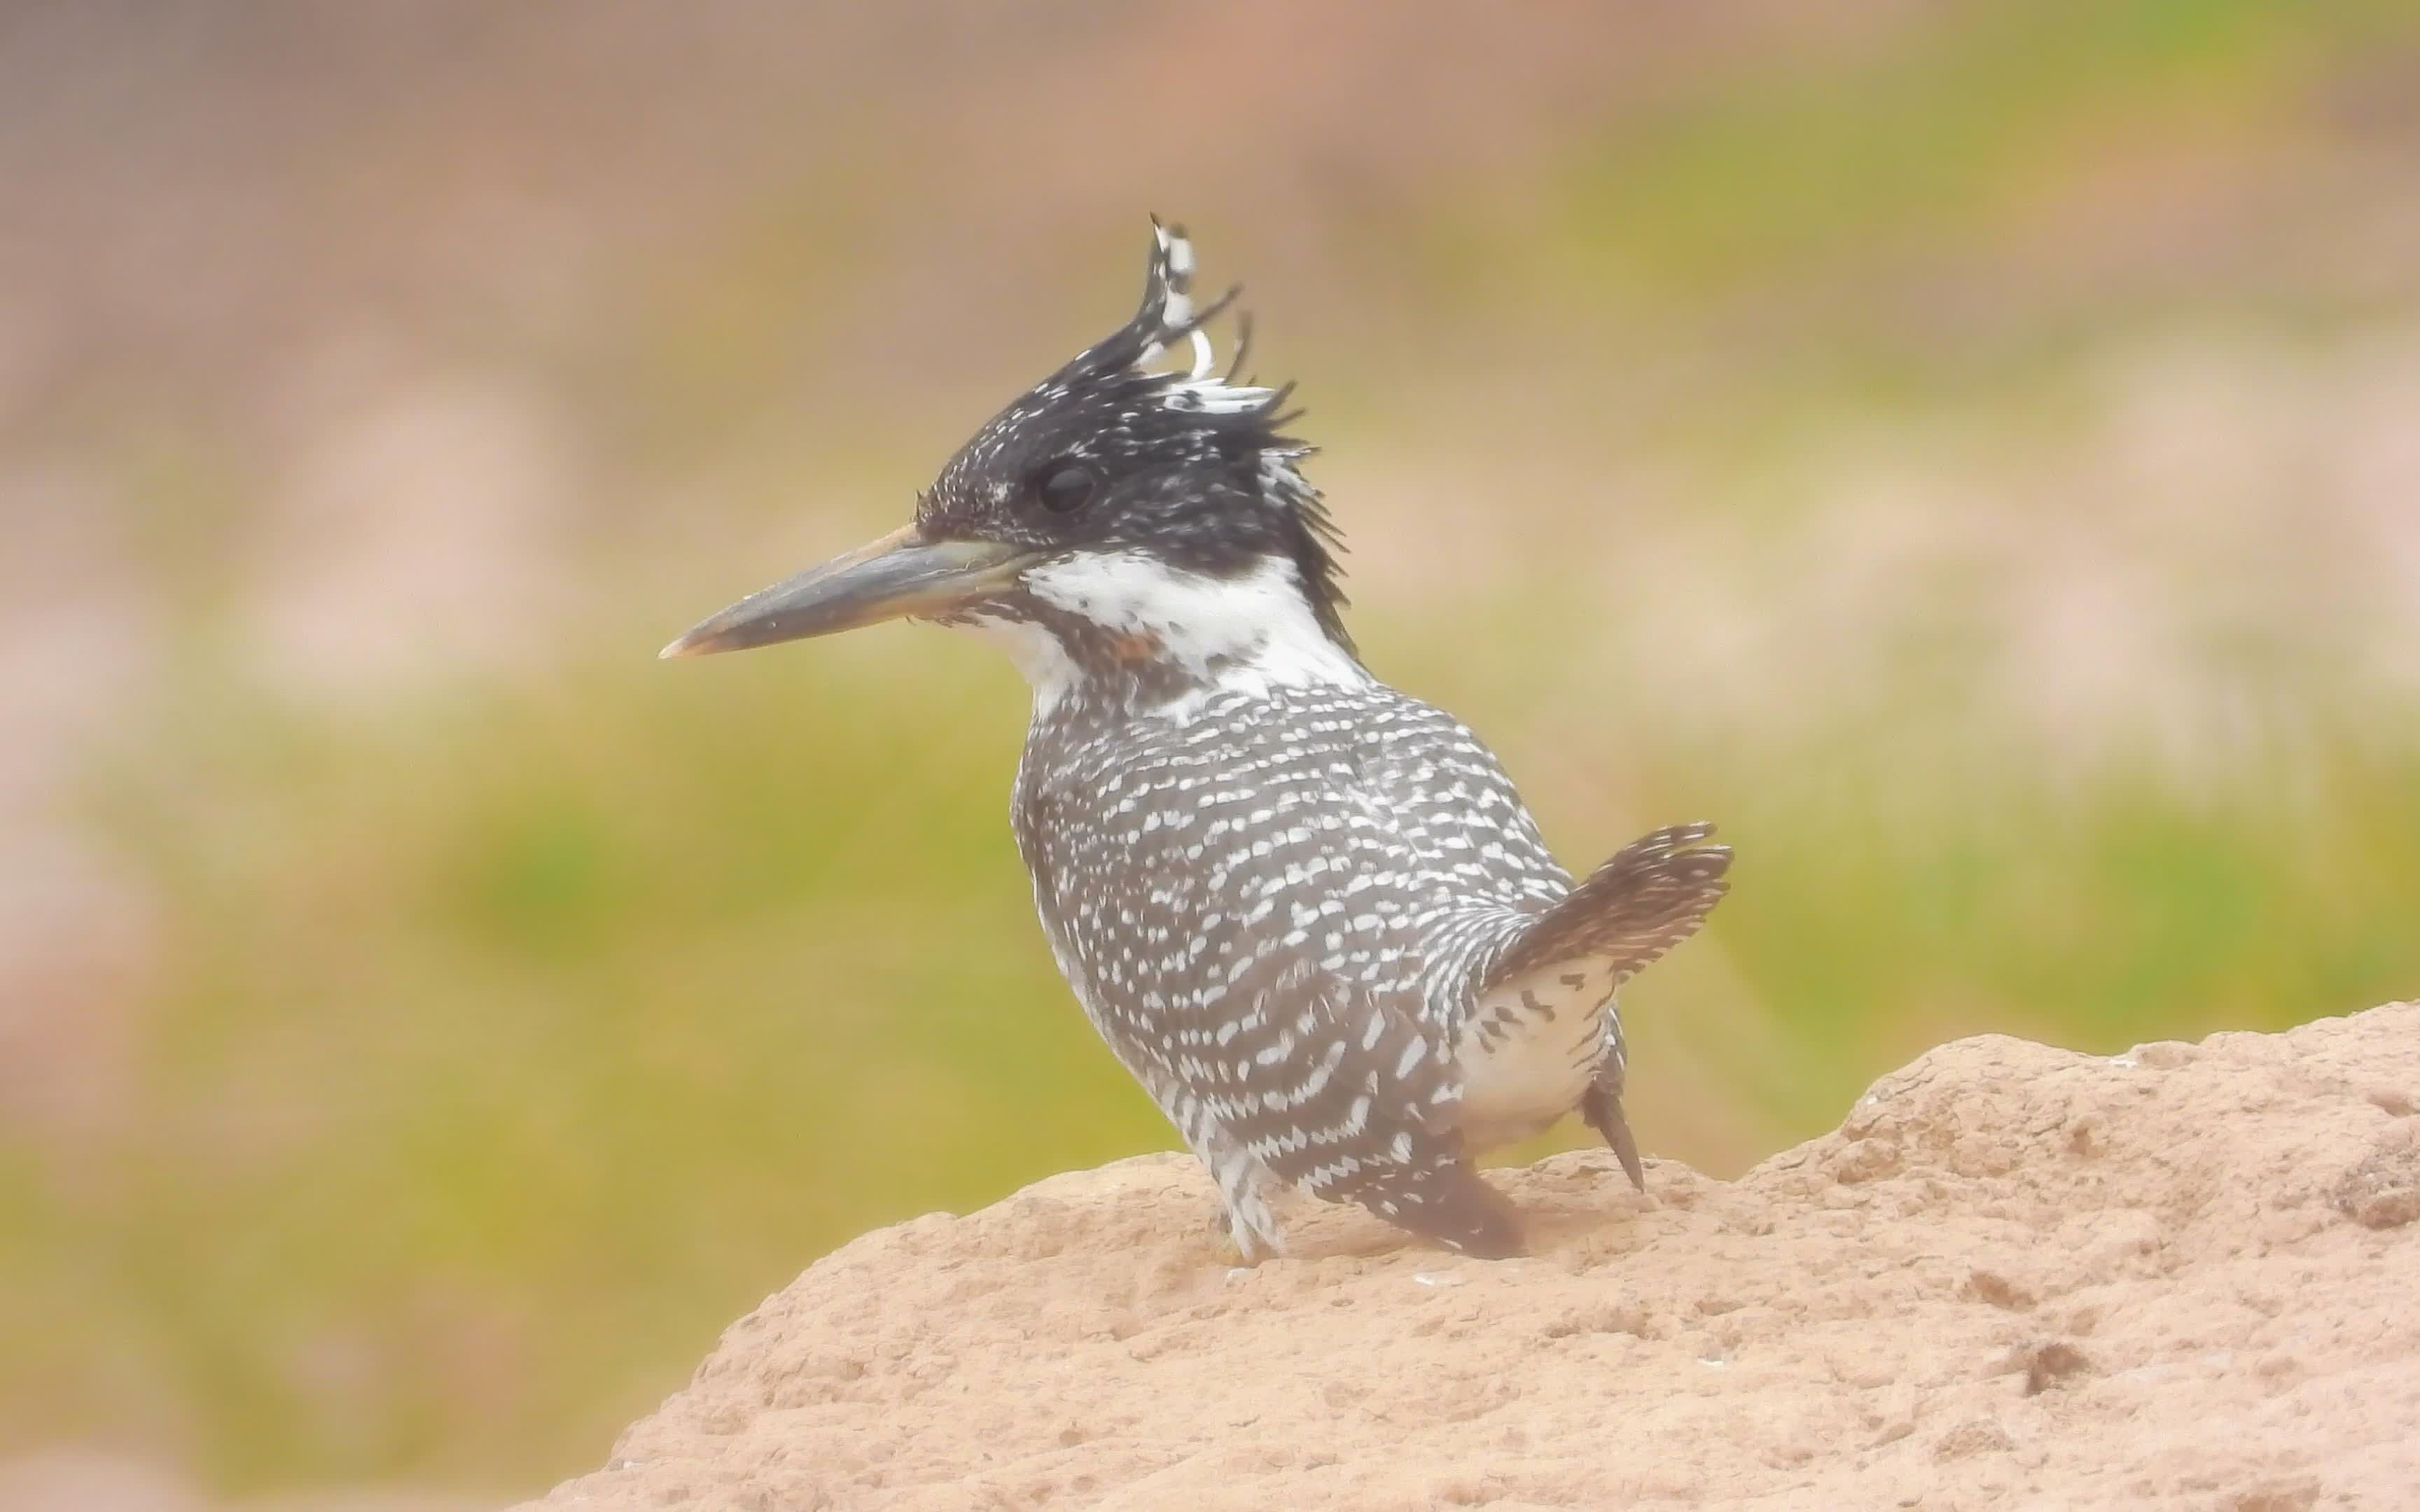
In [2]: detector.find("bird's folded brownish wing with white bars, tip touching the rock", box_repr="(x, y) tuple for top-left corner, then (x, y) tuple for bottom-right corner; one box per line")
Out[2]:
(1205, 951), (1522, 1258)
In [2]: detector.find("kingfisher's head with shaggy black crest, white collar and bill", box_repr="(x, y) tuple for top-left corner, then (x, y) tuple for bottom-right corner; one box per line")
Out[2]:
(663, 223), (1360, 699)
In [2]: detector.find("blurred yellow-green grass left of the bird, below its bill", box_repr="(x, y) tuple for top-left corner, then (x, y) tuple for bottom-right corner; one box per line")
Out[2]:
(20, 641), (1157, 1483)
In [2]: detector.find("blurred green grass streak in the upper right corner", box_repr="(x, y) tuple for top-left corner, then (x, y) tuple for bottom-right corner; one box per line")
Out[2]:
(1541, 0), (2408, 298)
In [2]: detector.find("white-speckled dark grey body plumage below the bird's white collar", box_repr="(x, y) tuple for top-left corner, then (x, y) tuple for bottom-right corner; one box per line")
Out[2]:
(1014, 680), (1723, 1253)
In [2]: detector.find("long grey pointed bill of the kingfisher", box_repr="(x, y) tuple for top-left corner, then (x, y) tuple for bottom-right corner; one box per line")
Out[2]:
(660, 525), (1036, 656)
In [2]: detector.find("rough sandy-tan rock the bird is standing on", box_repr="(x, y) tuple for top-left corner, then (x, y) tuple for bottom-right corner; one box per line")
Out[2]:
(524, 1004), (2420, 1512)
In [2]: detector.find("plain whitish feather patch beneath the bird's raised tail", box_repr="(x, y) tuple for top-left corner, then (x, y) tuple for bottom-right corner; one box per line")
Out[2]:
(1459, 962), (1614, 1154)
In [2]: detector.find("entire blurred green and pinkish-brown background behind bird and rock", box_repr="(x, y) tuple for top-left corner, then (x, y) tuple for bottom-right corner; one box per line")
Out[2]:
(0, 0), (2420, 1505)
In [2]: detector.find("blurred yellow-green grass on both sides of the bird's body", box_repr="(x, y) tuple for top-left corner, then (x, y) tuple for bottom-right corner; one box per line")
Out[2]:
(0, 605), (2420, 1483)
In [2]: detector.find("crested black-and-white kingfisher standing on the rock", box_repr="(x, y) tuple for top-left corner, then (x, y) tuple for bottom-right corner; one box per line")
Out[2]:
(663, 218), (1730, 1263)
